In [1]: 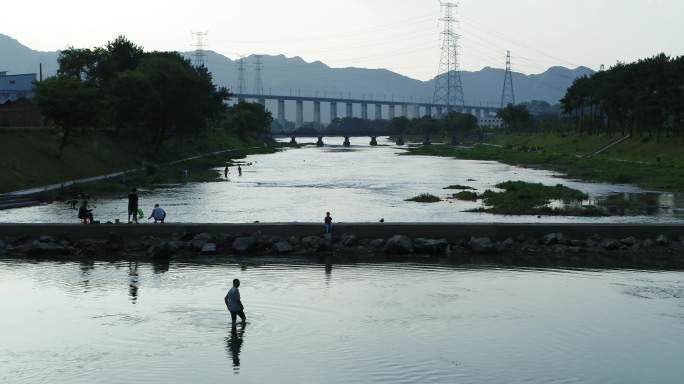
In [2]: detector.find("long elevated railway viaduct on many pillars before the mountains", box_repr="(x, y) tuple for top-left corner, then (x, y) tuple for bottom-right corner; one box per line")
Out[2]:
(231, 93), (499, 128)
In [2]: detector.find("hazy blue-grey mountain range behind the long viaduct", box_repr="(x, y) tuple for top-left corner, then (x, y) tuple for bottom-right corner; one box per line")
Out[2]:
(0, 34), (594, 118)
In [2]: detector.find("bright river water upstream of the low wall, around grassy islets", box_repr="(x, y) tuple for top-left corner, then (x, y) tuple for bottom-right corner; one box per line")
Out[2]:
(0, 137), (684, 223)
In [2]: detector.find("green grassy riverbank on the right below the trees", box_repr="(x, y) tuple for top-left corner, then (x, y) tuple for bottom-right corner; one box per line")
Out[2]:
(409, 134), (684, 192)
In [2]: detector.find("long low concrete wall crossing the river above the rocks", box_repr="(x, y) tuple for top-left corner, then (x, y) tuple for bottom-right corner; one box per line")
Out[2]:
(0, 223), (684, 241)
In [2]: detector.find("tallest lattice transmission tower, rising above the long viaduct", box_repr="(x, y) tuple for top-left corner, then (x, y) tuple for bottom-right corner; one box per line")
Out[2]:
(433, 3), (465, 112)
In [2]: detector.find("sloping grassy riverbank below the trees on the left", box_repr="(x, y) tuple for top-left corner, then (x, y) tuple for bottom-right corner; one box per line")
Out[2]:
(0, 129), (275, 193)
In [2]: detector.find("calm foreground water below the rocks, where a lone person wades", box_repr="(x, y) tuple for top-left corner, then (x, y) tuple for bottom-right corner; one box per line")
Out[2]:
(0, 259), (684, 384)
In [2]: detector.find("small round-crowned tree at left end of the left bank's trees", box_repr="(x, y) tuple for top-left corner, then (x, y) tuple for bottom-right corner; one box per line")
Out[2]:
(35, 77), (99, 154)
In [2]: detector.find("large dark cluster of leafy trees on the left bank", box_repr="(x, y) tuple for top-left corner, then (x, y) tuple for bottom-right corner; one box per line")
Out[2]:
(35, 36), (272, 150)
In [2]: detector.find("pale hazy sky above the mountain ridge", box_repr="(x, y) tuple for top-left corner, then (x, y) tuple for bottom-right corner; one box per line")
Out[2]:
(0, 0), (684, 80)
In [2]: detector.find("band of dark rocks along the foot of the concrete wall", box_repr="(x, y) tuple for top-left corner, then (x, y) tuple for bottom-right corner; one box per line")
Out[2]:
(0, 231), (684, 269)
